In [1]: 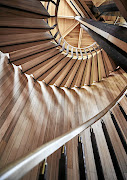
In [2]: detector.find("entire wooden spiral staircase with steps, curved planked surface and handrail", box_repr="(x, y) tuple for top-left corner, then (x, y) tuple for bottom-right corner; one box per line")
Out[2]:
(0, 0), (127, 180)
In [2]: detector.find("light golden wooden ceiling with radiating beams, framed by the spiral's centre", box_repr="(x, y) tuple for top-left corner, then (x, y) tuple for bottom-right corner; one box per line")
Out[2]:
(58, 0), (94, 48)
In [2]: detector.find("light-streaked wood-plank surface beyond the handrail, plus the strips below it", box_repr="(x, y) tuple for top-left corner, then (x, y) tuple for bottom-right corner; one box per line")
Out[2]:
(0, 53), (127, 180)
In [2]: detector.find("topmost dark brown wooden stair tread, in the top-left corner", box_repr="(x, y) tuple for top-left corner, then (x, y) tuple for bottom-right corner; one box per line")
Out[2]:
(0, 0), (49, 16)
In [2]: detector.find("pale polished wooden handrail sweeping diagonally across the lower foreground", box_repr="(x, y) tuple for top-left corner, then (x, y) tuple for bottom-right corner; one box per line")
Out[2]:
(0, 86), (127, 180)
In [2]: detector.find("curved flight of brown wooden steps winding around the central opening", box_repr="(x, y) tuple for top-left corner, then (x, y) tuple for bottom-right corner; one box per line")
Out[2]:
(0, 1), (116, 88)
